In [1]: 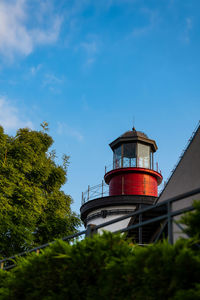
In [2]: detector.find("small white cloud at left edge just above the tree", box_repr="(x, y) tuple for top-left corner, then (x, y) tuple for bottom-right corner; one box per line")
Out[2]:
(0, 97), (34, 132)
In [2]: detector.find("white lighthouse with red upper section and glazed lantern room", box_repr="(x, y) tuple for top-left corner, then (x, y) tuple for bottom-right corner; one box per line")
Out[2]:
(80, 128), (162, 243)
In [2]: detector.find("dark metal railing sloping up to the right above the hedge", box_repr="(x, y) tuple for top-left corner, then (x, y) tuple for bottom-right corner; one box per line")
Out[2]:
(0, 188), (200, 270)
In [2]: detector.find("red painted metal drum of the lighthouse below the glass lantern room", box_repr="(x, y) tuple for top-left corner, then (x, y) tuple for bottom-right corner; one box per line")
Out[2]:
(104, 168), (162, 197)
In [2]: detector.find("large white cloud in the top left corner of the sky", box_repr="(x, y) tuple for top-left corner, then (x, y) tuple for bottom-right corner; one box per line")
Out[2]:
(0, 0), (62, 58)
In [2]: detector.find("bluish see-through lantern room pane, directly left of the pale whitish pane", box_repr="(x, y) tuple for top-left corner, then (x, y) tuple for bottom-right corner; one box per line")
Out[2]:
(123, 143), (136, 168)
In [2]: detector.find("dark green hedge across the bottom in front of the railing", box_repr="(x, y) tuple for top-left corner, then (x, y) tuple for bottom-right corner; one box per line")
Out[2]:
(0, 233), (200, 300)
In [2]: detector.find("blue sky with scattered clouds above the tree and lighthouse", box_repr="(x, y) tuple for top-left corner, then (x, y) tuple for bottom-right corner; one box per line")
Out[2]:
(0, 0), (200, 218)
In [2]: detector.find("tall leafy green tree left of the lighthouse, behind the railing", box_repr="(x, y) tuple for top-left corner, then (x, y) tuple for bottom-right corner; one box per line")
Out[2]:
(0, 123), (80, 257)
